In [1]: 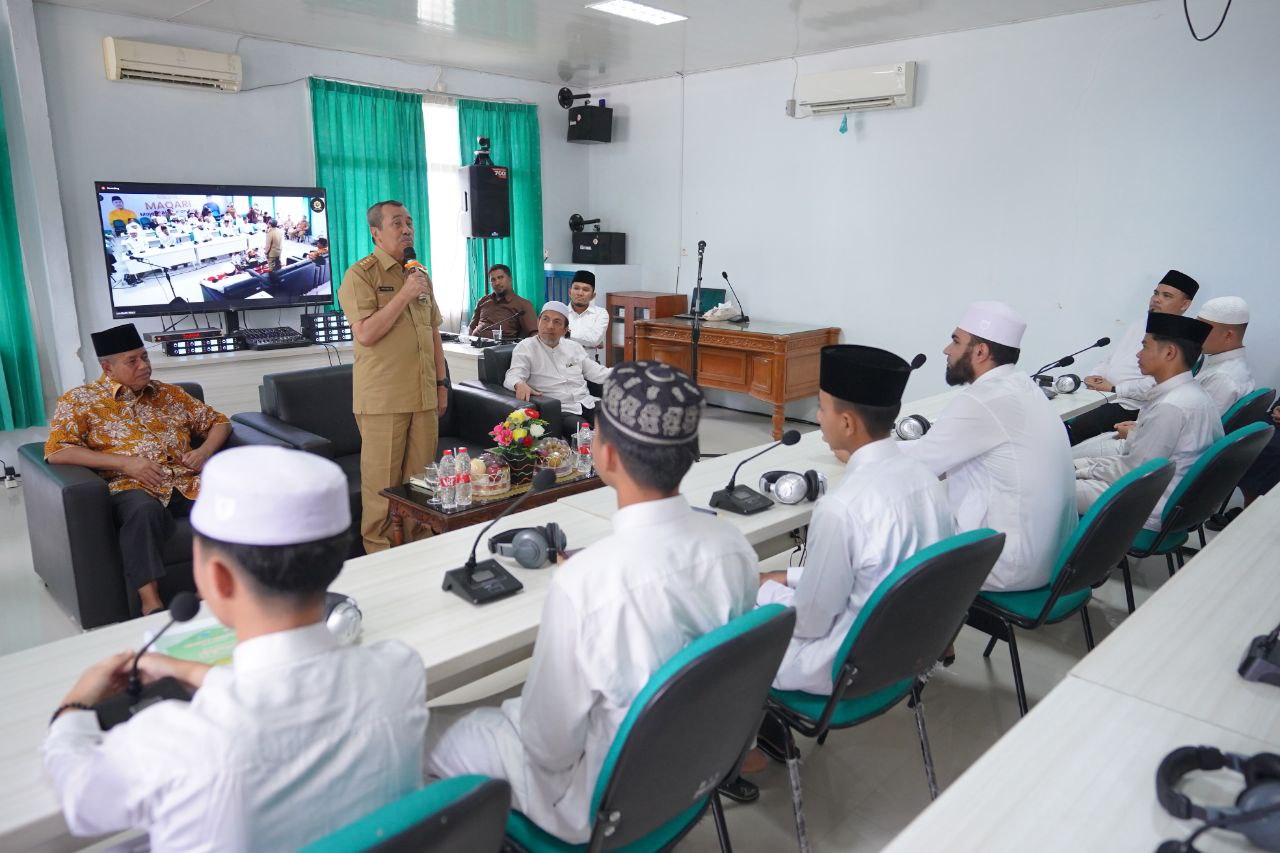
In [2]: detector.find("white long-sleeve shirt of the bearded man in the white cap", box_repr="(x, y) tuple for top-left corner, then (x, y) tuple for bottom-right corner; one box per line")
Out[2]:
(901, 365), (1079, 590)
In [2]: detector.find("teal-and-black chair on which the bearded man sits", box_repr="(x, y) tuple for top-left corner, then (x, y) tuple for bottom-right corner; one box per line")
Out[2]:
(969, 459), (1174, 715)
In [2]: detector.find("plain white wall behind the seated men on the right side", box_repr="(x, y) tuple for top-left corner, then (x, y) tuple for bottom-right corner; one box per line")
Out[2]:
(584, 3), (1280, 414)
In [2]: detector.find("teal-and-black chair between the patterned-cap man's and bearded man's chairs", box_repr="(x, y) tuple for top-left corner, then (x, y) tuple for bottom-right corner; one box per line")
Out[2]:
(768, 529), (1005, 852)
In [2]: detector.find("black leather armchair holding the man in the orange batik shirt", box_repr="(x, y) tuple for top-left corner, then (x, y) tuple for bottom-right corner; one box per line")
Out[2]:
(18, 382), (288, 629)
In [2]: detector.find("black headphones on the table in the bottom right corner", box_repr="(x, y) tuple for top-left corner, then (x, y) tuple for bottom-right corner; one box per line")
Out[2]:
(1156, 747), (1280, 853)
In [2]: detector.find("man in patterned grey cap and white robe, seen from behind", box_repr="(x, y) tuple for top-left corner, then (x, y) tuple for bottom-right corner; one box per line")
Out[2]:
(426, 361), (758, 844)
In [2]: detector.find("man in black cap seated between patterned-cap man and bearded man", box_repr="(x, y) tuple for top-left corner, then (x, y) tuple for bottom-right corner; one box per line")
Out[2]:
(756, 345), (952, 695)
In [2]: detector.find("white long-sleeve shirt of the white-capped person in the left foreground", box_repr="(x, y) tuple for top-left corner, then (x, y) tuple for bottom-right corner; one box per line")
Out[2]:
(44, 624), (428, 853)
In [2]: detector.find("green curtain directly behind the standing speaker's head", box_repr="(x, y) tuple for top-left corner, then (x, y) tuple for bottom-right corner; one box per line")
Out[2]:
(311, 77), (431, 306)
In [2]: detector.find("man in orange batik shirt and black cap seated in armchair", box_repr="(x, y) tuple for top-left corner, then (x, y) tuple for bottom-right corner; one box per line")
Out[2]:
(45, 323), (232, 615)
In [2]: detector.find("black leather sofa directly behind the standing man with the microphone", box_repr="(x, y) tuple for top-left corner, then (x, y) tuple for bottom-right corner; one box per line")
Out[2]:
(232, 364), (537, 556)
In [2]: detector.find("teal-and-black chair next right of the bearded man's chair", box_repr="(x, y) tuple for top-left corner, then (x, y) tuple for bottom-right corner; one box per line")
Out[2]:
(1120, 424), (1275, 613)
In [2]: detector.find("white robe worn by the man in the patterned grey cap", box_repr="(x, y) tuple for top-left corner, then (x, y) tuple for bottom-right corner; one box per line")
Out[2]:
(426, 496), (758, 843)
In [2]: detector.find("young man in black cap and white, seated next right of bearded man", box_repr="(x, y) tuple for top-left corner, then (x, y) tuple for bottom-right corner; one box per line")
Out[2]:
(1075, 313), (1222, 530)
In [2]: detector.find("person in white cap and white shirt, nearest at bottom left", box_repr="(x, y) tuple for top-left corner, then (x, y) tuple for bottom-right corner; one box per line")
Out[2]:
(44, 447), (428, 850)
